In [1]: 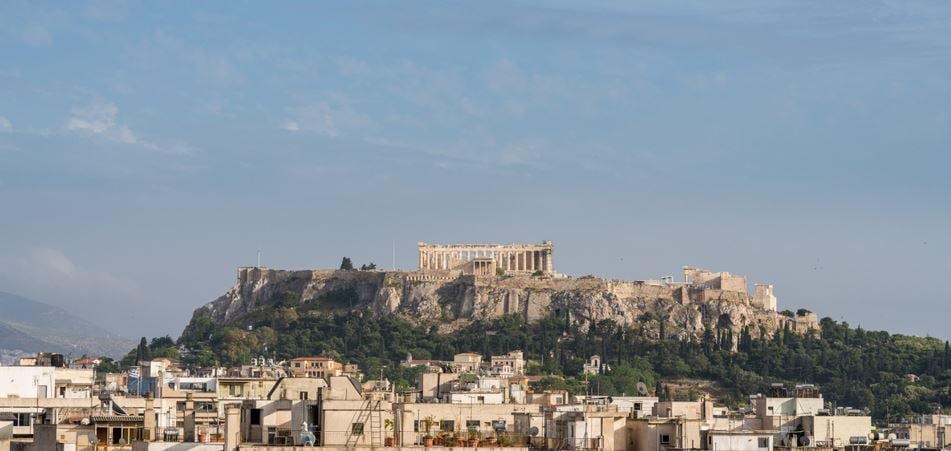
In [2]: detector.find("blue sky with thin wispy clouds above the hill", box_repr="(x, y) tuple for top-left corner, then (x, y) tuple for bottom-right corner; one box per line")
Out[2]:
(0, 0), (951, 339)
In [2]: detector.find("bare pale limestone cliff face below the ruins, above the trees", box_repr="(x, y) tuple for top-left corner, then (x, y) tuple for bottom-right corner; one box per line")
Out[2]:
(188, 268), (817, 339)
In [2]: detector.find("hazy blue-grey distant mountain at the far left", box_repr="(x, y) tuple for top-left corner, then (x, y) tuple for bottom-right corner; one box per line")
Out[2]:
(0, 291), (135, 357)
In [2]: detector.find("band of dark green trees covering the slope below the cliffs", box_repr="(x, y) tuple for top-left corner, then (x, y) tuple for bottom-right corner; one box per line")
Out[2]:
(171, 286), (951, 420)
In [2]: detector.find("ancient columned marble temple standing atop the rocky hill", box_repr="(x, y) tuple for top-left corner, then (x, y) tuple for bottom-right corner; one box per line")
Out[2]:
(418, 241), (555, 275)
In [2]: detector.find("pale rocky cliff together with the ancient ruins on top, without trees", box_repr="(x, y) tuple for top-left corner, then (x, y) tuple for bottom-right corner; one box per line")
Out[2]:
(194, 242), (818, 338)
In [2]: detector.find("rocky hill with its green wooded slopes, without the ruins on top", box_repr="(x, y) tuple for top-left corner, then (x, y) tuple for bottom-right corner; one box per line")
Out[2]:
(179, 270), (951, 420)
